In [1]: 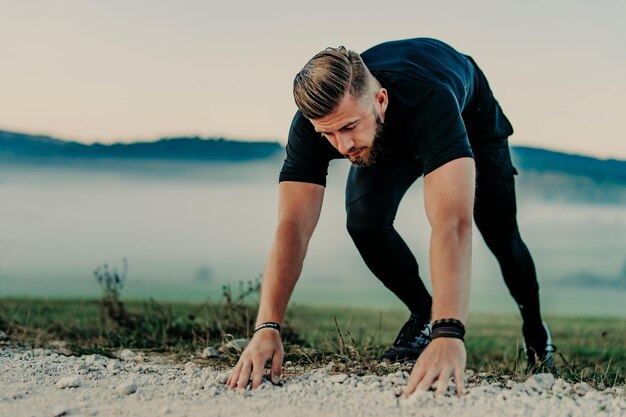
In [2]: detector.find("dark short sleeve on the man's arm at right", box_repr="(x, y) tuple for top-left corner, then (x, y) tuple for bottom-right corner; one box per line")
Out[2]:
(414, 87), (474, 175)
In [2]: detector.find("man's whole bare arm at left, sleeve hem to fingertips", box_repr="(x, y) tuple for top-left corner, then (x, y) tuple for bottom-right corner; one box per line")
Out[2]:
(226, 181), (324, 388)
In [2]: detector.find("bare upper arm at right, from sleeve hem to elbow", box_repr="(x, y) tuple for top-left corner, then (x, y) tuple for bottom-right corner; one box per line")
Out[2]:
(424, 158), (476, 227)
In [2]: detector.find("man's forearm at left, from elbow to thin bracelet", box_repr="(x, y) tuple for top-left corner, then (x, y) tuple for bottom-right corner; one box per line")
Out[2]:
(257, 222), (310, 325)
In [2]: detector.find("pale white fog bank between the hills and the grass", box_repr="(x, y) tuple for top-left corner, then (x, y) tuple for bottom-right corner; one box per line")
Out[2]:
(0, 159), (626, 316)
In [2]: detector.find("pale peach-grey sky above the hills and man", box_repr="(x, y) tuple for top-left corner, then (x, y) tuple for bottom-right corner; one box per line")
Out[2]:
(0, 0), (626, 159)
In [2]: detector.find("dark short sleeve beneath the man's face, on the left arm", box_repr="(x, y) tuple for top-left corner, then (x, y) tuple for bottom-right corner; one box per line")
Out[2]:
(278, 112), (341, 187)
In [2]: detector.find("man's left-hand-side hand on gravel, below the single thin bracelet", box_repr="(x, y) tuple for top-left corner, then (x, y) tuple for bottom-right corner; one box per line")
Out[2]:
(226, 328), (285, 389)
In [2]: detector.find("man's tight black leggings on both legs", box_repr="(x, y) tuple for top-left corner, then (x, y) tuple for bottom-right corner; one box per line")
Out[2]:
(346, 138), (539, 321)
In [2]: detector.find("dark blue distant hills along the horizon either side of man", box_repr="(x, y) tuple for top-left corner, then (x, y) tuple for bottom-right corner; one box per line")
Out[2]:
(0, 130), (626, 185)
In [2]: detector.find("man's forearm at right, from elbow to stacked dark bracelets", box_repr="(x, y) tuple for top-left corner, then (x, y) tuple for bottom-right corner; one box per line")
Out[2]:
(430, 222), (472, 323)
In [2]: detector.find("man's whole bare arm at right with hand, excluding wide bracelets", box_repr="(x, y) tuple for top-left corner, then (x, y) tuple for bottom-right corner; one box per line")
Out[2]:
(405, 158), (476, 394)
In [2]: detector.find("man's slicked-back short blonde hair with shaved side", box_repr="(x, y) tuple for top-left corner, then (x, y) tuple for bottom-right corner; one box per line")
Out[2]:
(293, 46), (370, 119)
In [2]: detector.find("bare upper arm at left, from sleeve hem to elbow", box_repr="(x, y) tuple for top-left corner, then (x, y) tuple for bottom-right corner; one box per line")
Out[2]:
(278, 181), (324, 236)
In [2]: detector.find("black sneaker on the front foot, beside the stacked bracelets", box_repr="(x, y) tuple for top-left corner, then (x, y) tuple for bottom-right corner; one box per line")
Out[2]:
(383, 314), (431, 362)
